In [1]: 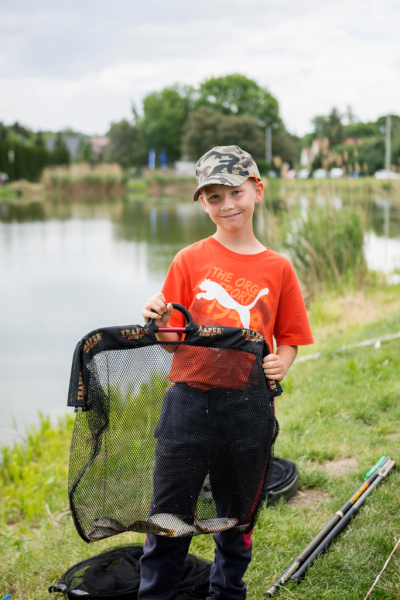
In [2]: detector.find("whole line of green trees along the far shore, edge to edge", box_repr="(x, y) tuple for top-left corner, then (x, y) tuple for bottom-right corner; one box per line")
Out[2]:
(0, 73), (400, 181)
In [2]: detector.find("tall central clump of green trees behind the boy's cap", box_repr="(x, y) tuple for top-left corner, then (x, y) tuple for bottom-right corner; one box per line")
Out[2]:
(105, 74), (298, 167)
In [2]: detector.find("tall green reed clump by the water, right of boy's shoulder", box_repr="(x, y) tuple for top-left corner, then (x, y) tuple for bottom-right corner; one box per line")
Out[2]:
(286, 206), (367, 291)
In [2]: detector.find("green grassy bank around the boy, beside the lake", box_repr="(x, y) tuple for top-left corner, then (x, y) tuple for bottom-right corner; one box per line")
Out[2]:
(0, 286), (400, 600)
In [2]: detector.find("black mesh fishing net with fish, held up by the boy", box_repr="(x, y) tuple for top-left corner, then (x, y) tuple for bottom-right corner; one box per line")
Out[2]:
(68, 304), (281, 542)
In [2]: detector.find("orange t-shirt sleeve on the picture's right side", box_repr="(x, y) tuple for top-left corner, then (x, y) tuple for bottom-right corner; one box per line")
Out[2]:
(274, 261), (314, 346)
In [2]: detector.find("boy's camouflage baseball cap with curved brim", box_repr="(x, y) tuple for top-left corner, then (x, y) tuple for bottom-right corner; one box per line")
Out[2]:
(193, 146), (260, 200)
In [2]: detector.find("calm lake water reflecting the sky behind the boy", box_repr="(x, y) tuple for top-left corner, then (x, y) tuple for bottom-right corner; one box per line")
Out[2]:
(0, 192), (400, 444)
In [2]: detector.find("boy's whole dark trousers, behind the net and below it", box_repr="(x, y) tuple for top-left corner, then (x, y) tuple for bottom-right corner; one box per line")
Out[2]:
(139, 383), (271, 600)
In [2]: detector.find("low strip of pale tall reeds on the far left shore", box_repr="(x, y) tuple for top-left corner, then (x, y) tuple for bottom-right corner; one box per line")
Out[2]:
(41, 163), (126, 194)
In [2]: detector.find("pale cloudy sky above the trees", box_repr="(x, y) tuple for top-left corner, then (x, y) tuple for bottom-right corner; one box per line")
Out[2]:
(0, 0), (400, 135)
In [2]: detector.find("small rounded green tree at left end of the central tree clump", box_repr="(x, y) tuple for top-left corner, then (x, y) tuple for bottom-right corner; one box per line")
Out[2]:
(104, 119), (146, 169)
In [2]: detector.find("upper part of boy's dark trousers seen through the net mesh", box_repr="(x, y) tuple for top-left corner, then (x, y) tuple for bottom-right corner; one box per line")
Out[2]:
(150, 383), (271, 525)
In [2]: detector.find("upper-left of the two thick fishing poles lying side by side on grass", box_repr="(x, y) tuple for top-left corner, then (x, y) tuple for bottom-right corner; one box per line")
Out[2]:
(265, 456), (390, 596)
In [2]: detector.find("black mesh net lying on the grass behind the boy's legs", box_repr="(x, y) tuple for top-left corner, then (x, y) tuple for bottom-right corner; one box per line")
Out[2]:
(49, 545), (211, 600)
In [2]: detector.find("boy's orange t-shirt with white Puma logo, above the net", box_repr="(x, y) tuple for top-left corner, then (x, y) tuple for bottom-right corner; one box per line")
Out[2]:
(162, 237), (313, 352)
